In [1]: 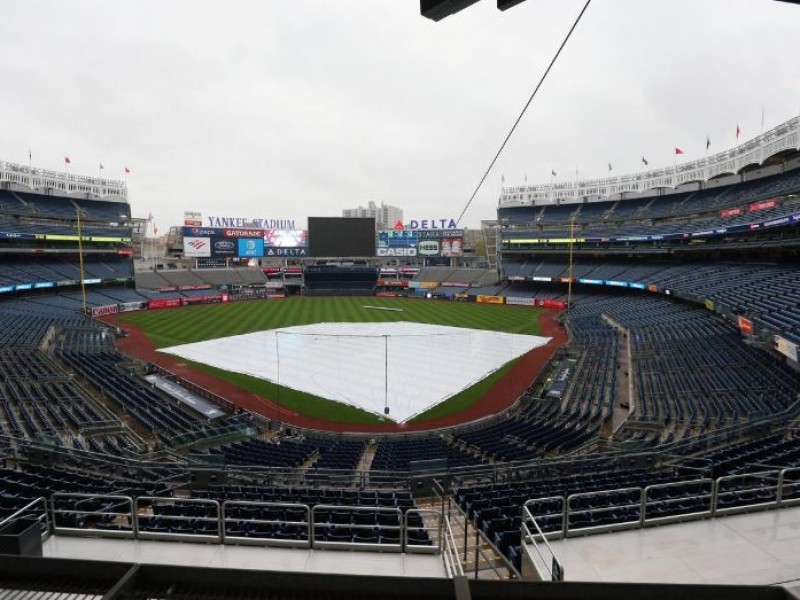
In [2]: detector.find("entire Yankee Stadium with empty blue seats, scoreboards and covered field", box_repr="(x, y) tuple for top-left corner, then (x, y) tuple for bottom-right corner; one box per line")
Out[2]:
(0, 1), (800, 600)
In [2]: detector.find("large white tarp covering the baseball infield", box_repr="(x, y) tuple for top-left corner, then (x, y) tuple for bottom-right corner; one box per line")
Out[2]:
(161, 322), (550, 422)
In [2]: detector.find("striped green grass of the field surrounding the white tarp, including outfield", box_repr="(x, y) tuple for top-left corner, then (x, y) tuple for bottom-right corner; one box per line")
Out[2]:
(119, 297), (540, 424)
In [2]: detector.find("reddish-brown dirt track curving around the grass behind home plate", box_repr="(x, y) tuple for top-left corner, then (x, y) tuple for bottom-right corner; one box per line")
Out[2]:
(101, 309), (567, 433)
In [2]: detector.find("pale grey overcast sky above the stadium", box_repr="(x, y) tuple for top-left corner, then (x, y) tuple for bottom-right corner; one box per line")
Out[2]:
(0, 0), (800, 230)
